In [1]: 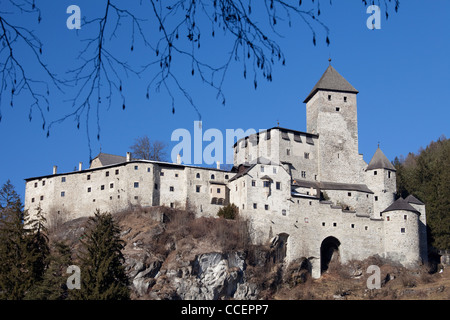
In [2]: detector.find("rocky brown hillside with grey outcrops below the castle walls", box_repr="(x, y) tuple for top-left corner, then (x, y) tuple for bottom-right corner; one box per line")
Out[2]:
(50, 207), (450, 300)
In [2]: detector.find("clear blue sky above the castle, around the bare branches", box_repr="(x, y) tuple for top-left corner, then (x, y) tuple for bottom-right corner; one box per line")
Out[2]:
(0, 0), (450, 197)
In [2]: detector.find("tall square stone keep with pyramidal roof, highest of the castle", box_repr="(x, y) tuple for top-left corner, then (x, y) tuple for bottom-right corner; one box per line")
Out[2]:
(304, 64), (363, 183)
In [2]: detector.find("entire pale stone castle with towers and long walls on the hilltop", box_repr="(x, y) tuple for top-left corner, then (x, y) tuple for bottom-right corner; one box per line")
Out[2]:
(25, 64), (427, 278)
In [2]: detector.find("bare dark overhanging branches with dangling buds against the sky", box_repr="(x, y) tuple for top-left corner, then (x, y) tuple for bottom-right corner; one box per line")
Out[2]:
(0, 0), (399, 158)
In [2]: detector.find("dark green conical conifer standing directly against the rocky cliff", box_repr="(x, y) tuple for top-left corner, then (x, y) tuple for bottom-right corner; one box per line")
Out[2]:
(69, 210), (130, 300)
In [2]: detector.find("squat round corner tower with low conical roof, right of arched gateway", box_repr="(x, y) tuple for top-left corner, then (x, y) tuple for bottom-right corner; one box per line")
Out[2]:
(383, 198), (421, 267)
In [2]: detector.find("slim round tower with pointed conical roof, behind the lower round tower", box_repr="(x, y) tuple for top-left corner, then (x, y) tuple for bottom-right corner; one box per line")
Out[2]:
(366, 147), (397, 219)
